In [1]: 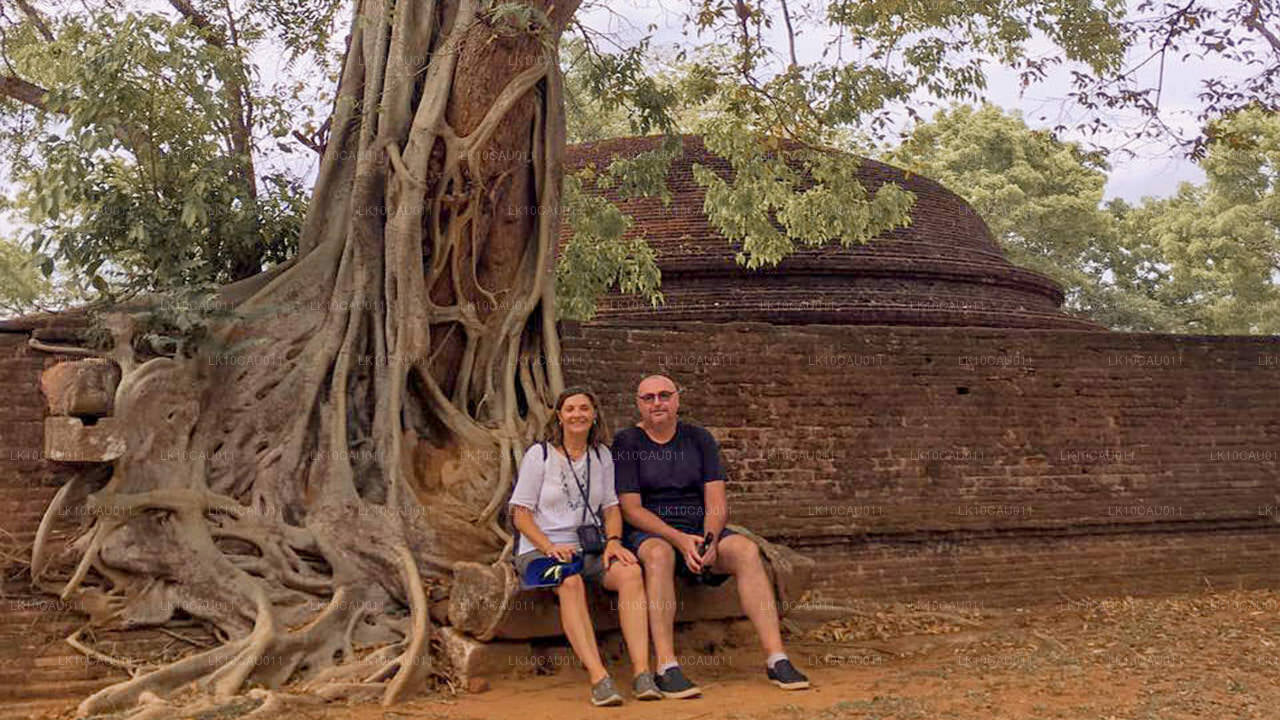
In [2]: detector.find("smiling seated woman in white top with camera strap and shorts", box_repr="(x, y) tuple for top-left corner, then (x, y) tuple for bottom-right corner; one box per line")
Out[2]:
(511, 388), (662, 706)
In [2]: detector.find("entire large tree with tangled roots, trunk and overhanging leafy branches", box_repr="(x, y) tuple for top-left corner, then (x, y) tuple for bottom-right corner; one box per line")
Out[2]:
(15, 0), (1264, 715)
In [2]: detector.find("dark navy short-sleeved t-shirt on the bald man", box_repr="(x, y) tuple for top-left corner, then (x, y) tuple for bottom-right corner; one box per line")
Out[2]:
(613, 420), (724, 533)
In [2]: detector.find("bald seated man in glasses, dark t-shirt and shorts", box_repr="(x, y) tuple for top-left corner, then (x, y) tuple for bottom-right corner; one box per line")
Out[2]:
(613, 375), (809, 698)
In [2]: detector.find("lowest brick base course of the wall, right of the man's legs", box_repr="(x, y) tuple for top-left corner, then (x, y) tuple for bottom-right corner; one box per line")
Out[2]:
(804, 524), (1280, 602)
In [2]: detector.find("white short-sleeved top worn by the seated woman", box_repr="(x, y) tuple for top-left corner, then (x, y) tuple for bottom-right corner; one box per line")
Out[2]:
(511, 443), (618, 555)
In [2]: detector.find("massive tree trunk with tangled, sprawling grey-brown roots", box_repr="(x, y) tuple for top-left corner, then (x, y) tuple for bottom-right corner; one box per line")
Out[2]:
(32, 0), (577, 715)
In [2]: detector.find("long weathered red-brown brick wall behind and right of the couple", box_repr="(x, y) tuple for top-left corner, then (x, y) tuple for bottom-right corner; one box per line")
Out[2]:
(563, 323), (1280, 606)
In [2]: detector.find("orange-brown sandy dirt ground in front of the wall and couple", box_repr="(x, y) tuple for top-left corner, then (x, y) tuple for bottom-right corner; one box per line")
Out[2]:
(35, 591), (1280, 720)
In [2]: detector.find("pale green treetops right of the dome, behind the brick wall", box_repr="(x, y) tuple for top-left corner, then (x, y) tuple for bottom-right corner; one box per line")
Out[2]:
(884, 105), (1280, 333)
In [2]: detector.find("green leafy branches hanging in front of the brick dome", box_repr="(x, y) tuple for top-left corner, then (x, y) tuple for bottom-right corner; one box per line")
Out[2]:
(558, 0), (1141, 318)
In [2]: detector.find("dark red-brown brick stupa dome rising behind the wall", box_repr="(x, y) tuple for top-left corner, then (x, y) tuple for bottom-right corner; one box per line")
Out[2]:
(564, 136), (1102, 329)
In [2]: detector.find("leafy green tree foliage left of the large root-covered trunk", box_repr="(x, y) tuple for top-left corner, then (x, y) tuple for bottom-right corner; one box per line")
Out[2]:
(0, 4), (335, 302)
